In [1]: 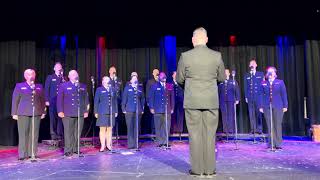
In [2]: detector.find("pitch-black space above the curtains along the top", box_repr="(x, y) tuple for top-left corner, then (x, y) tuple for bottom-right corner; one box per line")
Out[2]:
(0, 0), (320, 47)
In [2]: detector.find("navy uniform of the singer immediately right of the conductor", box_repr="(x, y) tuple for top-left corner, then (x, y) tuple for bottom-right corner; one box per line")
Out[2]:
(218, 79), (240, 134)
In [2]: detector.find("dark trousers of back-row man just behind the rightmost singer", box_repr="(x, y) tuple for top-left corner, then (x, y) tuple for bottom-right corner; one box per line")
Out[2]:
(248, 101), (262, 133)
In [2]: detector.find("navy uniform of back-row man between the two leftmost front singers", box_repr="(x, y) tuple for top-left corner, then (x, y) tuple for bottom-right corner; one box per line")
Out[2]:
(44, 73), (65, 140)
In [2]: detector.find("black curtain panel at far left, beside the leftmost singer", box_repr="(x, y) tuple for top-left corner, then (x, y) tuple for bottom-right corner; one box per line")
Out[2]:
(0, 41), (36, 145)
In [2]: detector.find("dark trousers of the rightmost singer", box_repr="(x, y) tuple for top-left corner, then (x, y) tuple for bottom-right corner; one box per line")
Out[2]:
(263, 108), (284, 147)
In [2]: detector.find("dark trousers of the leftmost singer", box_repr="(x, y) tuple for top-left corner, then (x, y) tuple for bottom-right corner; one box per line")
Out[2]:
(18, 116), (41, 158)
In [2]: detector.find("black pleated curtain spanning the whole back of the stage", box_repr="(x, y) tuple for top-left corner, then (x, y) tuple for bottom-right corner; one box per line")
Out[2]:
(0, 40), (320, 145)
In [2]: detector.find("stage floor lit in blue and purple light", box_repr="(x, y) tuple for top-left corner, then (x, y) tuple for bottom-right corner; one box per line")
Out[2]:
(0, 141), (320, 180)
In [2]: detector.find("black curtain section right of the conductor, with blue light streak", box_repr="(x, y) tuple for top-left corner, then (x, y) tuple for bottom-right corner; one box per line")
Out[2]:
(213, 43), (306, 136)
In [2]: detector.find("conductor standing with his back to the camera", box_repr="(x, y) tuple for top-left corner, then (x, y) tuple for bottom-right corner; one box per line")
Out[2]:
(177, 27), (225, 177)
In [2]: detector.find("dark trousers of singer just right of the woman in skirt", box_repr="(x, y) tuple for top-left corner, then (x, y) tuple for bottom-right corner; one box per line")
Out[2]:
(125, 112), (141, 149)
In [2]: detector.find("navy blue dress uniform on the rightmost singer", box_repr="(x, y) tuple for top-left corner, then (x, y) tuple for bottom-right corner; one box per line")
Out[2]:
(259, 79), (288, 148)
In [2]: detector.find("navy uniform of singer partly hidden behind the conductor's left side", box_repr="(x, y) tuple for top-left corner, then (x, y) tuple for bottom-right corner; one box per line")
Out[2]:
(171, 82), (184, 133)
